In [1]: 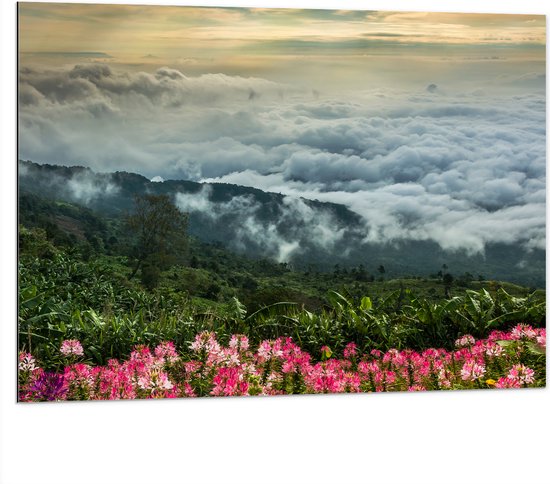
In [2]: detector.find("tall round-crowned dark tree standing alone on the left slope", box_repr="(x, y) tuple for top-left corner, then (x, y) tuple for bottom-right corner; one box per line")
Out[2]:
(126, 195), (188, 289)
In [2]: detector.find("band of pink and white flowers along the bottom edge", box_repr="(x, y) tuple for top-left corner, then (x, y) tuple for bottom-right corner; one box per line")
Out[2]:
(19, 324), (546, 402)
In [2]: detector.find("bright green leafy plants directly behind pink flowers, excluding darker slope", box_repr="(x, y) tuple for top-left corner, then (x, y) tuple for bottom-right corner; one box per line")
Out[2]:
(19, 239), (546, 367)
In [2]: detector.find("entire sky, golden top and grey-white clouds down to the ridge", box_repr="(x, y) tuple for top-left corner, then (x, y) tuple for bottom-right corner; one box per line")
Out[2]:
(18, 3), (546, 253)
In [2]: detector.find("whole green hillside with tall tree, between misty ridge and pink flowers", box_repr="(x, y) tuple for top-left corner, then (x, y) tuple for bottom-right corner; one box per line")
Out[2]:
(19, 188), (546, 369)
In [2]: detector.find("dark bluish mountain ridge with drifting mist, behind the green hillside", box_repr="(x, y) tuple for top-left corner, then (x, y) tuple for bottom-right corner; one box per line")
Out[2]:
(19, 160), (545, 287)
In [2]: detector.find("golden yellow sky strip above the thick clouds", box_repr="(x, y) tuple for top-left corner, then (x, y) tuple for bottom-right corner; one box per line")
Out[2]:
(19, 3), (546, 62)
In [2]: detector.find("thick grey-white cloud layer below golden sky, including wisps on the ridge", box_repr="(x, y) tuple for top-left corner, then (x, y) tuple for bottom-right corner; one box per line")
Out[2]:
(19, 64), (546, 255)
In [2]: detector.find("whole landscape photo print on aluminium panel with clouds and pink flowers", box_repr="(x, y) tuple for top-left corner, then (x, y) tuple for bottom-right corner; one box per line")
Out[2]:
(17, 2), (546, 402)
